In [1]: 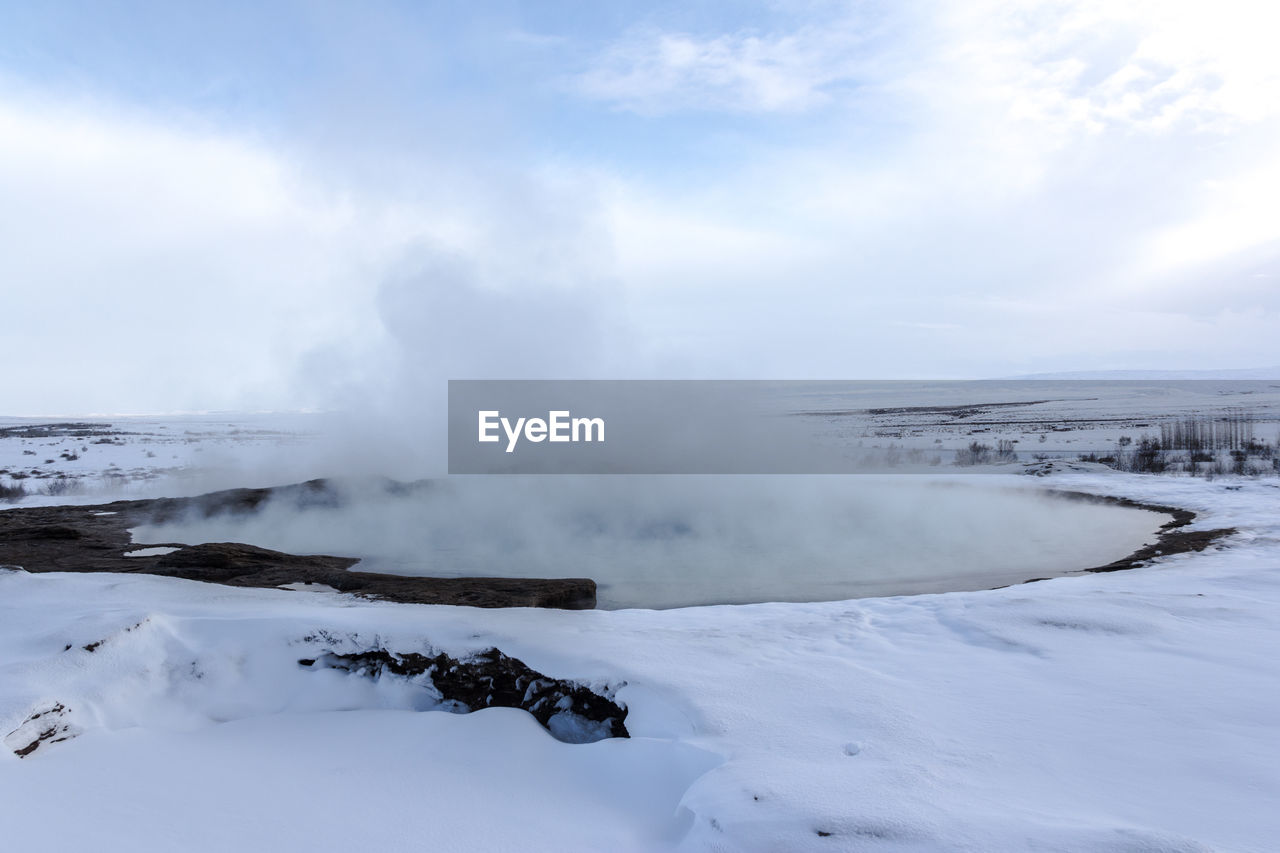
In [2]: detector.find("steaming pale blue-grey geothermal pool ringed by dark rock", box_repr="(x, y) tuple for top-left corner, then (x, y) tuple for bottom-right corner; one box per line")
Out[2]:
(133, 476), (1169, 610)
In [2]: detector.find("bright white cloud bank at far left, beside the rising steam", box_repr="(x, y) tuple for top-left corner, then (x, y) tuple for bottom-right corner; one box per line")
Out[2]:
(0, 97), (428, 412)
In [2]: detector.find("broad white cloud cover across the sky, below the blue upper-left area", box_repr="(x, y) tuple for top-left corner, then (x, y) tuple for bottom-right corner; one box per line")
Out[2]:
(0, 1), (1280, 411)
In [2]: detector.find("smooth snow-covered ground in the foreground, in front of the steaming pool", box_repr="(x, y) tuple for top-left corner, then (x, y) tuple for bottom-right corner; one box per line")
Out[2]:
(0, 409), (1280, 852)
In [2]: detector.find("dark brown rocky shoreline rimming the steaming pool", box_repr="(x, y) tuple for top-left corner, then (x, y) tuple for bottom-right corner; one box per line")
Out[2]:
(0, 480), (1236, 610)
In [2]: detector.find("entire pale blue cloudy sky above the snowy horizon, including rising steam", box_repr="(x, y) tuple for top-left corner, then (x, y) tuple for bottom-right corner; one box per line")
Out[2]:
(0, 0), (1280, 415)
